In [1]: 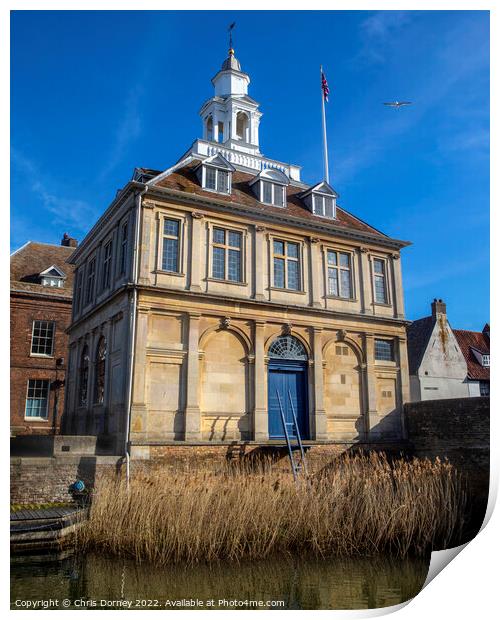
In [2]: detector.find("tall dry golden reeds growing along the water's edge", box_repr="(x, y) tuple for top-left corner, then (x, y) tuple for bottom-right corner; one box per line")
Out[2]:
(78, 453), (466, 564)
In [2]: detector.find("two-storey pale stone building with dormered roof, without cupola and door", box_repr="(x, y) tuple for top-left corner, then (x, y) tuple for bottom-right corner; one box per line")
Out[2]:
(64, 48), (409, 458)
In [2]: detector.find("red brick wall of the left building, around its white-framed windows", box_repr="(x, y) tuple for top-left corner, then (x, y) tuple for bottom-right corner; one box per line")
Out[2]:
(10, 293), (71, 434)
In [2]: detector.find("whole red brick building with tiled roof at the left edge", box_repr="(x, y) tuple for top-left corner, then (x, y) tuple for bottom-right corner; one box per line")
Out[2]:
(10, 234), (77, 435)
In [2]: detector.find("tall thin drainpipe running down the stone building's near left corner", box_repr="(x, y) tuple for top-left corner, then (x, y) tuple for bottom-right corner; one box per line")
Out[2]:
(125, 185), (149, 488)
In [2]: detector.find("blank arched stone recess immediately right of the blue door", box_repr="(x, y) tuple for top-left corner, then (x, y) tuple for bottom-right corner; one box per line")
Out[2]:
(323, 338), (366, 439)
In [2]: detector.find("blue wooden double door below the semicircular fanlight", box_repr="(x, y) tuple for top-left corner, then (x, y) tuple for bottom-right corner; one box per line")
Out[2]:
(268, 360), (308, 439)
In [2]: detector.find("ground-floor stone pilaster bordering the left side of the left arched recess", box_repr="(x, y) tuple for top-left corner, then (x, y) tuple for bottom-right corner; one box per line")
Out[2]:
(184, 313), (201, 441)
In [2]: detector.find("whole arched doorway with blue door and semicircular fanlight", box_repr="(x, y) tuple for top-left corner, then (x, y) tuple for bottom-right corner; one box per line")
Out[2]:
(267, 336), (309, 439)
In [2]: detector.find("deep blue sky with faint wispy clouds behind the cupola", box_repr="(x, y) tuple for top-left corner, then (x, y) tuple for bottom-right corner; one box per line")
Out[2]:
(11, 11), (489, 329)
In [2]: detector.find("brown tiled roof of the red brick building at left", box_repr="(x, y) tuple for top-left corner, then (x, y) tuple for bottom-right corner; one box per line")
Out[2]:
(10, 241), (75, 298)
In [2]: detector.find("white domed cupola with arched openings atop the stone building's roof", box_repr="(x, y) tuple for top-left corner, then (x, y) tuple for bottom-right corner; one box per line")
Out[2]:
(200, 47), (262, 155)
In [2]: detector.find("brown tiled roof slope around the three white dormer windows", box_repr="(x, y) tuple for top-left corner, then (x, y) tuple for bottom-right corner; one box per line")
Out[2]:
(158, 161), (388, 239)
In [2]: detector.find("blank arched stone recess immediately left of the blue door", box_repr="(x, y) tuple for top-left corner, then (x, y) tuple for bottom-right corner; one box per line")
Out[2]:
(200, 328), (252, 441)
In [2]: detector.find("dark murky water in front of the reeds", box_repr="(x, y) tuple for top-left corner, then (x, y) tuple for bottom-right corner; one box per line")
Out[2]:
(11, 553), (429, 609)
